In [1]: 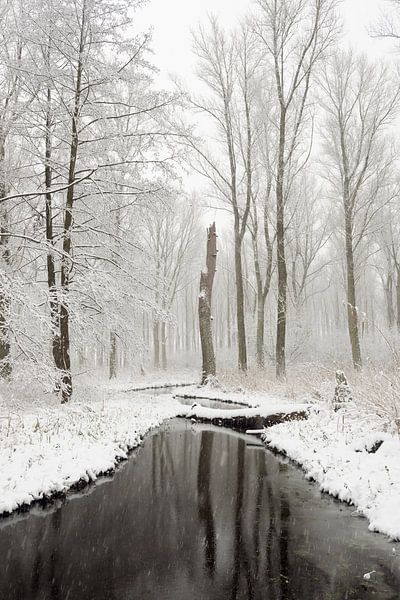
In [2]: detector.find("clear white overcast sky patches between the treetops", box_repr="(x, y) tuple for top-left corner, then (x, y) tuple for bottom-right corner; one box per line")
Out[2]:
(137, 0), (386, 85)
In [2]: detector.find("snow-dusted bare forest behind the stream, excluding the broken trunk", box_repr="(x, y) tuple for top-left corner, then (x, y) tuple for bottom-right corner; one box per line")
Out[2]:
(0, 0), (400, 401)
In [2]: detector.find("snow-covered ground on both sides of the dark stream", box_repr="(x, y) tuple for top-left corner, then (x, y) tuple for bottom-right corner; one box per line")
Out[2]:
(0, 373), (400, 539)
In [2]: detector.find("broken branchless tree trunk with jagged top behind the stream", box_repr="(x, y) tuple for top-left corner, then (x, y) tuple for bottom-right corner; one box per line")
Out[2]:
(199, 223), (217, 385)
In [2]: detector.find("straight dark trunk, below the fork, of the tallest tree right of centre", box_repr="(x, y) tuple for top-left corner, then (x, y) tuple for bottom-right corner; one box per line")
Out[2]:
(276, 107), (287, 378)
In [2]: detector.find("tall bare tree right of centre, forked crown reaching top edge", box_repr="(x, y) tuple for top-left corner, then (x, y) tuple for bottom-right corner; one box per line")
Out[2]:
(254, 0), (337, 377)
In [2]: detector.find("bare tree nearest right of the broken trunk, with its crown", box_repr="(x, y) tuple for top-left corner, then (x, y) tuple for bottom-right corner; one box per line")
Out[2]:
(190, 18), (253, 371)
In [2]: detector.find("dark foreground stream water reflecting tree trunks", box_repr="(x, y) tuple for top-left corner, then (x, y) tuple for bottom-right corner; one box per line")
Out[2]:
(0, 421), (400, 600)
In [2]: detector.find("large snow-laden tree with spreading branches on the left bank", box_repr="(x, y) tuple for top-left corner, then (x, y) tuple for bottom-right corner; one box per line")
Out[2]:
(0, 0), (180, 402)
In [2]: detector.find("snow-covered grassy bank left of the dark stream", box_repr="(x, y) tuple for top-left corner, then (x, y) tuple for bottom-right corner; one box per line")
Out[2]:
(0, 391), (182, 514)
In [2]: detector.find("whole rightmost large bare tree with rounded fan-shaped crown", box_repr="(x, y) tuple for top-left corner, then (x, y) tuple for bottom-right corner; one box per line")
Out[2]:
(322, 51), (399, 368)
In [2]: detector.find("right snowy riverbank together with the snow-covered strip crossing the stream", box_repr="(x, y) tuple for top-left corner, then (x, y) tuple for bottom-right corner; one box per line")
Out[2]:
(178, 386), (400, 539)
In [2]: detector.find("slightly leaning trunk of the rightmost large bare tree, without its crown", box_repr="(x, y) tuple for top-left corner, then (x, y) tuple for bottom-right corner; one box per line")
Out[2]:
(345, 211), (362, 369)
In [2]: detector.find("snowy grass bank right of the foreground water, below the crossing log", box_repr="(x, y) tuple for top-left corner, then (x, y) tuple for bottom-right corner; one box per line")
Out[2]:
(263, 406), (400, 540)
